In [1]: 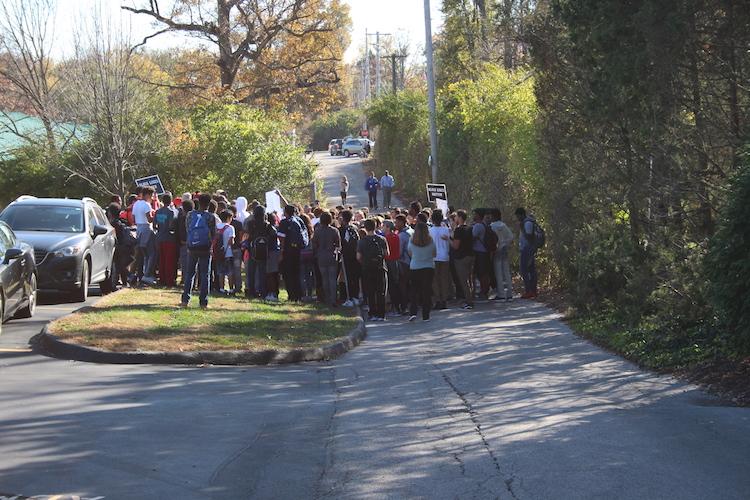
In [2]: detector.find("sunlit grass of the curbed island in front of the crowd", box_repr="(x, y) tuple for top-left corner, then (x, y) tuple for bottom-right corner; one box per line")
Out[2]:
(49, 289), (357, 352)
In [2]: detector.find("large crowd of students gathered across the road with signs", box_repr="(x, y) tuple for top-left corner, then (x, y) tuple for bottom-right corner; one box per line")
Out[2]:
(107, 180), (544, 321)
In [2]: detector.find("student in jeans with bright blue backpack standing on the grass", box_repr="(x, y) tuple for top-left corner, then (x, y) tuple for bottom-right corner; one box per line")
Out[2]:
(180, 194), (216, 309)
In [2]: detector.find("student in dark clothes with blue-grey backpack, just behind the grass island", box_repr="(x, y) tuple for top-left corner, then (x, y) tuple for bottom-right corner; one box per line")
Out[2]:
(278, 205), (309, 302)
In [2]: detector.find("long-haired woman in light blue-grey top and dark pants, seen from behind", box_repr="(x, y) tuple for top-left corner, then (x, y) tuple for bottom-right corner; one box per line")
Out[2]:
(409, 222), (437, 321)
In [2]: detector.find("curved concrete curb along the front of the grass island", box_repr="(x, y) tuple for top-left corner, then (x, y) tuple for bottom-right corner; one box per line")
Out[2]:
(32, 318), (367, 365)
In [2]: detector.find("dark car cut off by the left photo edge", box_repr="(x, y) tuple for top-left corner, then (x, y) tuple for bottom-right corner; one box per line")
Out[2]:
(0, 222), (37, 331)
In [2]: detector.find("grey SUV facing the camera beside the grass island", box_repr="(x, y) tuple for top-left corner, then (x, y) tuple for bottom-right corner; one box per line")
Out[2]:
(0, 196), (115, 302)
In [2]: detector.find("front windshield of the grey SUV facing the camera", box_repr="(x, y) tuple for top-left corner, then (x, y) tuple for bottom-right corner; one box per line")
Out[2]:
(0, 205), (83, 233)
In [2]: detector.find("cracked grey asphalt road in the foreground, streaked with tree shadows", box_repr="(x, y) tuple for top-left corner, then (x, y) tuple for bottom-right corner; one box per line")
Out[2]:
(0, 302), (750, 499)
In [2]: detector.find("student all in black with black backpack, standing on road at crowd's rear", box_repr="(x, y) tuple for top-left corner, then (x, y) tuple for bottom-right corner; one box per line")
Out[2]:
(357, 219), (388, 321)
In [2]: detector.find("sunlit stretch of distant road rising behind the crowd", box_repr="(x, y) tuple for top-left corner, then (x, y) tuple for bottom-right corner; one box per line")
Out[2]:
(315, 152), (404, 208)
